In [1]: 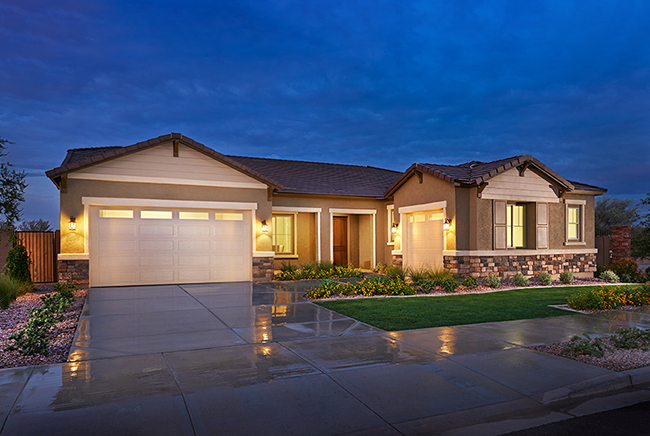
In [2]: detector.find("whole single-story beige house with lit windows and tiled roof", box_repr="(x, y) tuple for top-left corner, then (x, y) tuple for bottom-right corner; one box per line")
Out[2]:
(46, 133), (606, 286)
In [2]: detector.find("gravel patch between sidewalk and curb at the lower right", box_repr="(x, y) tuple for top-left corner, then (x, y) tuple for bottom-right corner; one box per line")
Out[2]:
(529, 337), (650, 371)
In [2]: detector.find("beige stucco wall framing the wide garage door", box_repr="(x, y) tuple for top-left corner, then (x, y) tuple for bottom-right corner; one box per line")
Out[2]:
(60, 179), (271, 253)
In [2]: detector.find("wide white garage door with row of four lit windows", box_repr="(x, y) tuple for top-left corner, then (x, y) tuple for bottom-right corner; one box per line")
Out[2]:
(89, 206), (252, 286)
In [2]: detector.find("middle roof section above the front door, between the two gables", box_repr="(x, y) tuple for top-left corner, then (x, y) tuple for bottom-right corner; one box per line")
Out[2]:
(229, 156), (402, 198)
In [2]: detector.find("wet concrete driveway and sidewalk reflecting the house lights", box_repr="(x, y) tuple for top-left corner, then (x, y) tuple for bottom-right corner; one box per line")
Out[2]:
(0, 282), (650, 436)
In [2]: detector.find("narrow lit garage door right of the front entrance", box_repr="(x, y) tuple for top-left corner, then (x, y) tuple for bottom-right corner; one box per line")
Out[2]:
(406, 210), (444, 268)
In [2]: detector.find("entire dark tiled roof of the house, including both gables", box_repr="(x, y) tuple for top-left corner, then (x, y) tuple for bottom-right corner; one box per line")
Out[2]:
(46, 133), (607, 198)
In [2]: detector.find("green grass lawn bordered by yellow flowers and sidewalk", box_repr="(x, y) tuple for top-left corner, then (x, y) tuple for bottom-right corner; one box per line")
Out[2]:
(317, 286), (636, 331)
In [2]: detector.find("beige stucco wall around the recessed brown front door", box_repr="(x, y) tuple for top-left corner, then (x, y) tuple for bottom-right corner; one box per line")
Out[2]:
(273, 194), (393, 267)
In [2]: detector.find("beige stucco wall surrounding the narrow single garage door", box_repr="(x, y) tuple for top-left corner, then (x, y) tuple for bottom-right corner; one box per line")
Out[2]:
(394, 174), (456, 250)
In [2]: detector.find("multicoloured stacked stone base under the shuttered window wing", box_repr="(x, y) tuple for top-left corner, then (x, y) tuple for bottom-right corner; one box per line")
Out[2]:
(443, 254), (596, 278)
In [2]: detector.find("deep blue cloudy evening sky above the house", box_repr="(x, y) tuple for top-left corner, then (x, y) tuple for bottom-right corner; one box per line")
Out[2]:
(0, 0), (650, 227)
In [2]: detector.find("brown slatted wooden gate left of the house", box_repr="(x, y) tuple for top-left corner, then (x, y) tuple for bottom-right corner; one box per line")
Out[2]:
(16, 230), (60, 283)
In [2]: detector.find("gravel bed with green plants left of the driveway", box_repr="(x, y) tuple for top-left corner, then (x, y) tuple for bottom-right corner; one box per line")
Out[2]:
(0, 286), (88, 368)
